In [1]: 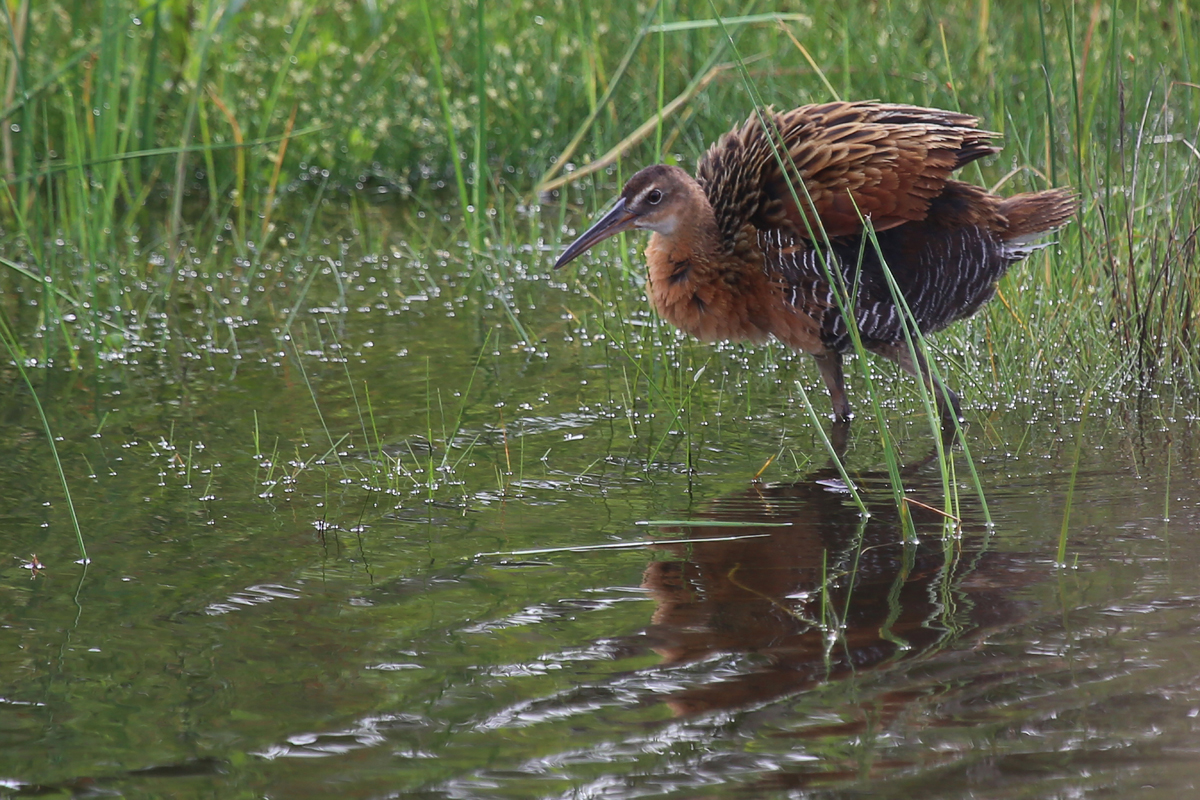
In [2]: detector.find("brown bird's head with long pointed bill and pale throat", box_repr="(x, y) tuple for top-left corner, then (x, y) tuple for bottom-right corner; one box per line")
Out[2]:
(554, 164), (703, 270)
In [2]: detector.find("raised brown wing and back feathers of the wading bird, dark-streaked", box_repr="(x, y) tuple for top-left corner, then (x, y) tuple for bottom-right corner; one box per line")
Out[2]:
(697, 102), (998, 249)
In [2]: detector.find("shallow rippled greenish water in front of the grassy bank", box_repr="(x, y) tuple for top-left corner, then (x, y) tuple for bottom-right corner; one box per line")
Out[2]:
(0, 239), (1200, 798)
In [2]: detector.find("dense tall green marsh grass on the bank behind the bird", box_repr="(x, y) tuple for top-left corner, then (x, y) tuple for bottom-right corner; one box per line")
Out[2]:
(0, 0), (1200, 383)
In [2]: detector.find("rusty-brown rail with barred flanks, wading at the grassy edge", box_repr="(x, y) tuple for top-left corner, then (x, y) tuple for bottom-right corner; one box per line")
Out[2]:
(554, 101), (1079, 425)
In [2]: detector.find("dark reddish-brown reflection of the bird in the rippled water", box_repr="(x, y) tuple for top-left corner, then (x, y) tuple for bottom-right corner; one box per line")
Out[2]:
(643, 455), (1036, 733)
